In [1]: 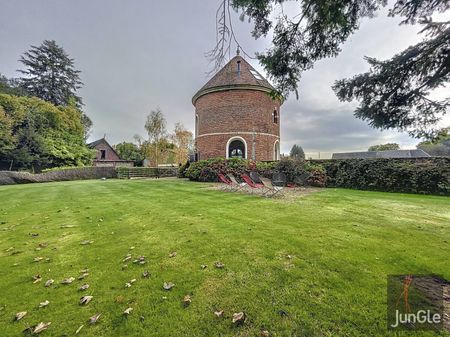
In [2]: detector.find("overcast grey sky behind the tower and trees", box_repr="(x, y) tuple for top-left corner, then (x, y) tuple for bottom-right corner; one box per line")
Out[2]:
(0, 0), (449, 157)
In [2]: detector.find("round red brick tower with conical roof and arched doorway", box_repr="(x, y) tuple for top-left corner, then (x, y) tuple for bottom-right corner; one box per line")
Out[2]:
(192, 53), (282, 161)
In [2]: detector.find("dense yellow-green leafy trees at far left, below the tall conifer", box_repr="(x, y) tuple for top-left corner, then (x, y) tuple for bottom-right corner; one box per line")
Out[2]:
(0, 94), (93, 170)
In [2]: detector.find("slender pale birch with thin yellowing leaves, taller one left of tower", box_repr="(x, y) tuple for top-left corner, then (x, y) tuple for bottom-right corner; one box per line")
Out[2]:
(145, 107), (167, 166)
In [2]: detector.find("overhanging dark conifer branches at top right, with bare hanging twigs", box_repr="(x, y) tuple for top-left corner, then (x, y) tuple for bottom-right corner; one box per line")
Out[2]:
(209, 0), (450, 137)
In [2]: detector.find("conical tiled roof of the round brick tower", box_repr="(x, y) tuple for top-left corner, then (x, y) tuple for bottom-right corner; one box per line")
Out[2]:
(192, 55), (274, 105)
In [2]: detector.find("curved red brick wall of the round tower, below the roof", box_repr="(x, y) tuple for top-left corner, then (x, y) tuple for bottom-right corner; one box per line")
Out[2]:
(195, 90), (280, 160)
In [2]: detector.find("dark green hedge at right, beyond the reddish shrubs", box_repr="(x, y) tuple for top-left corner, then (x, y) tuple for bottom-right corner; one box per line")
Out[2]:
(322, 158), (450, 195)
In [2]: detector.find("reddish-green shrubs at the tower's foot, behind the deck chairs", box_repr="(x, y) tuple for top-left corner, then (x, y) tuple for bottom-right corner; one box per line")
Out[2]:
(182, 158), (326, 187)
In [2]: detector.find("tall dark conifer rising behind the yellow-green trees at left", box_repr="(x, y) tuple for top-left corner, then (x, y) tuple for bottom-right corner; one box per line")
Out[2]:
(19, 40), (83, 107)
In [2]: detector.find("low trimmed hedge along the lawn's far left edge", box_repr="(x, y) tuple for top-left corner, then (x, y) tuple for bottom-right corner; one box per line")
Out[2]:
(0, 166), (117, 185)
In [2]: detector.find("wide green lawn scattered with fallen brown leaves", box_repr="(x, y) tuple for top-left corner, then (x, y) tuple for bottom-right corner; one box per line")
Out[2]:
(0, 180), (450, 337)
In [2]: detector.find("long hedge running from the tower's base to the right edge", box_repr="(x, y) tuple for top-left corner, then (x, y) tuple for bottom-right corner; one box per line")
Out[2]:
(179, 157), (450, 195)
